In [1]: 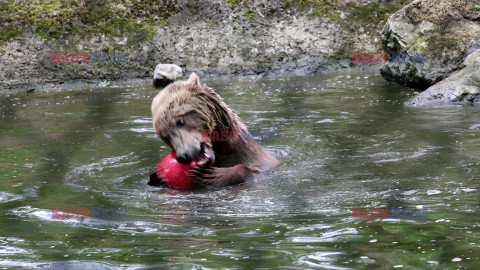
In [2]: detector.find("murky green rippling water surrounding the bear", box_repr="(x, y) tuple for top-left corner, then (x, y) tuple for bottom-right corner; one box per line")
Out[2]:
(0, 70), (480, 269)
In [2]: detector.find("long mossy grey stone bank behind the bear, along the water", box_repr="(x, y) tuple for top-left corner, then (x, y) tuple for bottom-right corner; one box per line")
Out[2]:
(0, 0), (410, 91)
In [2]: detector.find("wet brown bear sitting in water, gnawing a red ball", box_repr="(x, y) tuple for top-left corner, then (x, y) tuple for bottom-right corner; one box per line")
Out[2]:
(148, 73), (279, 187)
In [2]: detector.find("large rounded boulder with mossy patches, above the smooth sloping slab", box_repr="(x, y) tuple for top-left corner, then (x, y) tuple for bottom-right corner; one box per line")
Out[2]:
(380, 0), (480, 89)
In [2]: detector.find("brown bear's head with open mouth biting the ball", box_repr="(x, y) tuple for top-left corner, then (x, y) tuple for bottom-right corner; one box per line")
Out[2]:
(152, 73), (243, 165)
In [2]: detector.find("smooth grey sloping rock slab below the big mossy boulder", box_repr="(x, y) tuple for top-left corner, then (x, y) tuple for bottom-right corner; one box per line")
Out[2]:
(406, 50), (480, 106)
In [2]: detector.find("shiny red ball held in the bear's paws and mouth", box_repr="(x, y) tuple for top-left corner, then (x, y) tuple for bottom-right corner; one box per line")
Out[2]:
(157, 152), (198, 189)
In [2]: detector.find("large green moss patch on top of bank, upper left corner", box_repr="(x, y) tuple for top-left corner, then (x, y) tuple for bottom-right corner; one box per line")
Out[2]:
(0, 0), (176, 46)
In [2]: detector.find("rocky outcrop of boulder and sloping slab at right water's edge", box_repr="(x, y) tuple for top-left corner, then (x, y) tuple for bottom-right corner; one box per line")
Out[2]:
(381, 0), (480, 106)
